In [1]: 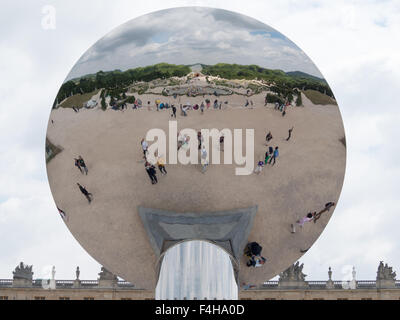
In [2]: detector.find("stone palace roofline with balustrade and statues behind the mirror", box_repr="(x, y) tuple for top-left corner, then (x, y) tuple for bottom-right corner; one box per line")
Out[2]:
(0, 261), (400, 300)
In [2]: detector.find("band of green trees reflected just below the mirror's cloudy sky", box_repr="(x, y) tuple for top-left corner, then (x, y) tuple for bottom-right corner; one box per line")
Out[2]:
(53, 63), (334, 107)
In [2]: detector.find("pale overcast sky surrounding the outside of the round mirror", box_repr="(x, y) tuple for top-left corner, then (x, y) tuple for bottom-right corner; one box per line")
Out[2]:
(0, 0), (400, 280)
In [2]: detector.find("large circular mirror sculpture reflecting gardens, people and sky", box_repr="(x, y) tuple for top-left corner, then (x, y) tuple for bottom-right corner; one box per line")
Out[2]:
(46, 7), (346, 289)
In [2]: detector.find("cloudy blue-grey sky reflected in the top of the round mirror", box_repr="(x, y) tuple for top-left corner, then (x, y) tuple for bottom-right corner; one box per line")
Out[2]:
(68, 7), (321, 79)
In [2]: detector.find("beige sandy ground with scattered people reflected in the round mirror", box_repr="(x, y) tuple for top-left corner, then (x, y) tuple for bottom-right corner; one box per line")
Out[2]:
(47, 95), (346, 289)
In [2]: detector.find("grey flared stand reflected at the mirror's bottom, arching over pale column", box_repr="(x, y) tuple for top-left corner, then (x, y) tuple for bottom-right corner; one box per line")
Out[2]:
(138, 206), (257, 280)
